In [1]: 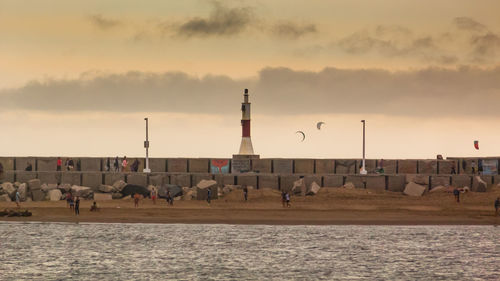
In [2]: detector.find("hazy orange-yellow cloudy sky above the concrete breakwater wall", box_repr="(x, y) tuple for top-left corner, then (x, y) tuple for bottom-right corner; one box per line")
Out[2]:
(0, 0), (500, 159)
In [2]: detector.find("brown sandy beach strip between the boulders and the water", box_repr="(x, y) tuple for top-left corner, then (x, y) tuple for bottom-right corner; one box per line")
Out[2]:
(0, 188), (500, 225)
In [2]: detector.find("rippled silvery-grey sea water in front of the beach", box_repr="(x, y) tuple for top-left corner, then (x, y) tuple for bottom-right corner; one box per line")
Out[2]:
(0, 222), (500, 280)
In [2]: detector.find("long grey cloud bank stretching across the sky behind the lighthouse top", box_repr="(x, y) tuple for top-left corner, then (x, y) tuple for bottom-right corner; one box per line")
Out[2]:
(0, 67), (500, 118)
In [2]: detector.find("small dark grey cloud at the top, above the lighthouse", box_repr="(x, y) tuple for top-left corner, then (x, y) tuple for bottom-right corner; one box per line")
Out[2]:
(172, 1), (253, 37)
